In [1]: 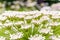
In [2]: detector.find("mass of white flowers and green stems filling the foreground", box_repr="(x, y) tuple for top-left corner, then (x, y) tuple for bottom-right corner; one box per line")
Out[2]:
(0, 11), (60, 40)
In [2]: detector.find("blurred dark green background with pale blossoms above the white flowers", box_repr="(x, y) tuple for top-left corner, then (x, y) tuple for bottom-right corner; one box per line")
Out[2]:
(0, 0), (60, 11)
